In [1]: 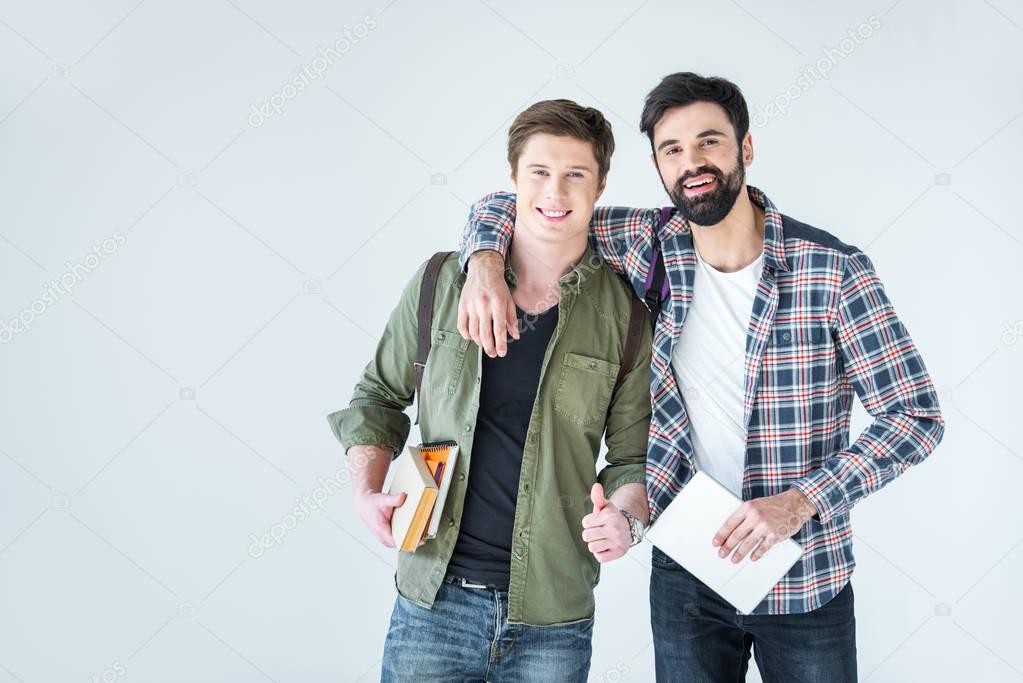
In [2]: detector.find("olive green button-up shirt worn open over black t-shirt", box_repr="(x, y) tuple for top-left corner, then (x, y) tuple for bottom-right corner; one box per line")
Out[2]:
(328, 247), (651, 625)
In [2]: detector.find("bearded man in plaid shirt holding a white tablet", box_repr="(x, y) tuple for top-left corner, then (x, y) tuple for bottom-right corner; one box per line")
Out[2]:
(459, 73), (944, 681)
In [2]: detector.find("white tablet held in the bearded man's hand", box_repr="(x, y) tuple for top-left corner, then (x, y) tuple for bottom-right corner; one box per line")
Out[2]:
(647, 472), (803, 614)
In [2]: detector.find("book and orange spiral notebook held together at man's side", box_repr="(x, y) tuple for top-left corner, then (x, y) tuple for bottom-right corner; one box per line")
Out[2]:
(388, 442), (458, 552)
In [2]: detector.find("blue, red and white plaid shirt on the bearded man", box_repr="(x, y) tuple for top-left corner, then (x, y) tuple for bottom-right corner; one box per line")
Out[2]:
(461, 187), (944, 614)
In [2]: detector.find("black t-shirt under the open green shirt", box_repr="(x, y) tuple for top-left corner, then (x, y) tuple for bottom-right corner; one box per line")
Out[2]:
(448, 306), (558, 588)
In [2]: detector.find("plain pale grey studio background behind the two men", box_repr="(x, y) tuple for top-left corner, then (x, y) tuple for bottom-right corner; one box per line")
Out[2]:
(0, 0), (1023, 683)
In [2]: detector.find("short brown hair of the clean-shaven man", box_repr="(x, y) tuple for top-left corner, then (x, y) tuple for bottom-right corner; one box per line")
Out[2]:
(508, 99), (615, 182)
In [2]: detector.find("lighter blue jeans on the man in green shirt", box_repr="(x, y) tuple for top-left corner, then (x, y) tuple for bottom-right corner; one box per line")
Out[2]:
(381, 583), (593, 683)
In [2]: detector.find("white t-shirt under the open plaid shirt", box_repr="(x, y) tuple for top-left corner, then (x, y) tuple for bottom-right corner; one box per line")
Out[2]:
(671, 245), (764, 498)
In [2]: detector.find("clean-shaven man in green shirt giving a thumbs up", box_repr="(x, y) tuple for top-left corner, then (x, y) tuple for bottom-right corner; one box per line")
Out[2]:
(329, 100), (651, 682)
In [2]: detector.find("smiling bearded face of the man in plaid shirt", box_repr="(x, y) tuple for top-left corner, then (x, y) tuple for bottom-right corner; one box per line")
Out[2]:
(653, 101), (753, 226)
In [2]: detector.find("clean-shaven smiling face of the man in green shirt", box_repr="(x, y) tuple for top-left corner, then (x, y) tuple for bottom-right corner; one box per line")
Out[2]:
(512, 133), (605, 243)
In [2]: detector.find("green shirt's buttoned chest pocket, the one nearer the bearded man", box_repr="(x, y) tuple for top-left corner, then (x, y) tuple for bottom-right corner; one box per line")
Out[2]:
(554, 353), (621, 425)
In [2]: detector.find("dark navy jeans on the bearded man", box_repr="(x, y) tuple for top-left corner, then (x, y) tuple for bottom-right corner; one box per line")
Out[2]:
(650, 547), (856, 683)
